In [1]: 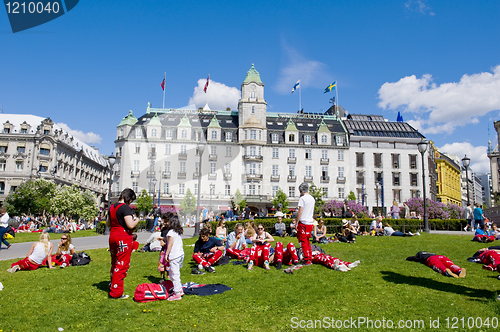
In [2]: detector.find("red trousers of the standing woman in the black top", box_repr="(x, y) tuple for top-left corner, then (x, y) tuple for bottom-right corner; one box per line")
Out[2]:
(109, 231), (133, 298)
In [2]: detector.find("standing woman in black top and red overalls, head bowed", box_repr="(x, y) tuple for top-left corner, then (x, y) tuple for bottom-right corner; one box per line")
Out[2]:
(106, 188), (139, 299)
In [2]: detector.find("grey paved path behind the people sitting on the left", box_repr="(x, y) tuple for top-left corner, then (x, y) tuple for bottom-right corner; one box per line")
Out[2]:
(0, 227), (194, 261)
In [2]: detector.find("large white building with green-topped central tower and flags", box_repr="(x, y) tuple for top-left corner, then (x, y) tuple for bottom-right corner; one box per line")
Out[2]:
(113, 65), (428, 215)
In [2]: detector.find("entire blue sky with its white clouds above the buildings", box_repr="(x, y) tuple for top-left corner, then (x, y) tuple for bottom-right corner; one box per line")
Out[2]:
(0, 0), (500, 173)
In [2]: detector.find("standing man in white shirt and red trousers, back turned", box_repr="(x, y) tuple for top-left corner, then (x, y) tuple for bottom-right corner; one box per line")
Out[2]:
(297, 182), (316, 265)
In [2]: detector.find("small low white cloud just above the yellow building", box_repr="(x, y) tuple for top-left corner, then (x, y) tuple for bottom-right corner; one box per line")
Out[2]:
(438, 142), (490, 173)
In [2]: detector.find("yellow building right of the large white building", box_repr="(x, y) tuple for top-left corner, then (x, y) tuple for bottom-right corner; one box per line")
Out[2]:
(434, 148), (462, 206)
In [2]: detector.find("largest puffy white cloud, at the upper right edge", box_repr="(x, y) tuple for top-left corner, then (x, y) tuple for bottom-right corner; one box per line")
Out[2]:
(378, 65), (500, 134)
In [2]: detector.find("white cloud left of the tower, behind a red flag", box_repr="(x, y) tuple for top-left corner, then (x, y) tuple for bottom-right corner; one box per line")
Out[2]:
(189, 78), (241, 111)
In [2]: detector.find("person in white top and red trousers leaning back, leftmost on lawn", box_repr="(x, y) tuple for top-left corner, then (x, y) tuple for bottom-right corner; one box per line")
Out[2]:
(7, 233), (55, 273)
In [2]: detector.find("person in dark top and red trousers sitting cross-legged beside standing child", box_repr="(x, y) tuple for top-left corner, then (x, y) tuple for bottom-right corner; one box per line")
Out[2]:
(193, 228), (224, 273)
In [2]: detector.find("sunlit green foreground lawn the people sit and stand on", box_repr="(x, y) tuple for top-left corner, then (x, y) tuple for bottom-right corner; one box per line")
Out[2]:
(0, 234), (500, 332)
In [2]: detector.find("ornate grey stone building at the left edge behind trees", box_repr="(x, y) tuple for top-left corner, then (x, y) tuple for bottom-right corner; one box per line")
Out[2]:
(0, 114), (110, 207)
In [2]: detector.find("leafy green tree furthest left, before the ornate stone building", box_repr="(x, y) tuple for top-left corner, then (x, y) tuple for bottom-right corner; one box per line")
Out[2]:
(5, 179), (57, 215)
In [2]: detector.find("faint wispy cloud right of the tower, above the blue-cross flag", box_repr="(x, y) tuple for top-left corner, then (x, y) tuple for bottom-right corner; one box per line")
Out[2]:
(275, 42), (331, 94)
